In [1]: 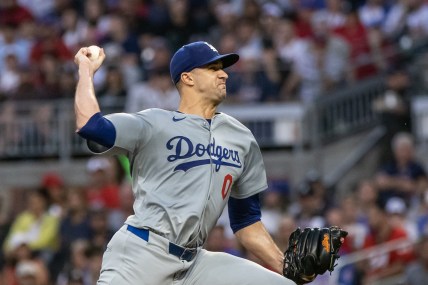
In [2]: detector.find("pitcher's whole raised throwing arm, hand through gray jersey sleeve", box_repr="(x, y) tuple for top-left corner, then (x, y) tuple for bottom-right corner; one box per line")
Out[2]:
(74, 48), (152, 154)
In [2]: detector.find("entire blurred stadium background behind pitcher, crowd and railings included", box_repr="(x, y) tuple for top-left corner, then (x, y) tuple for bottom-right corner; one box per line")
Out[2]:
(0, 0), (428, 285)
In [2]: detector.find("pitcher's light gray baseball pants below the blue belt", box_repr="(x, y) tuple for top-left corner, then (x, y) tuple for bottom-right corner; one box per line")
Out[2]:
(97, 226), (295, 285)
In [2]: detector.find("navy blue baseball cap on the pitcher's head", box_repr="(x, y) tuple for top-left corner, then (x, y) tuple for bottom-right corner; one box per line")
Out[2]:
(169, 41), (239, 84)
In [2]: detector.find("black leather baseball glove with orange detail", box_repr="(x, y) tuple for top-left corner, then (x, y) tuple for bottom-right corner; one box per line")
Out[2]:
(283, 226), (348, 284)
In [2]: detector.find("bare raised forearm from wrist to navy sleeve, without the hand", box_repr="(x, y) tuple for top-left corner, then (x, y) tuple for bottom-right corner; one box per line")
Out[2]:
(74, 63), (100, 130)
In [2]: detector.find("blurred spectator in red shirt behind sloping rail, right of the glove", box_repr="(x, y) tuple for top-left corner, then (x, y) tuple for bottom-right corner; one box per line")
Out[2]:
(363, 199), (414, 284)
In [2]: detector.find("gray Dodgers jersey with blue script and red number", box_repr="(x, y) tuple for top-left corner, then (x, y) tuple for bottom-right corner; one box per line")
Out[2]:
(100, 109), (267, 247)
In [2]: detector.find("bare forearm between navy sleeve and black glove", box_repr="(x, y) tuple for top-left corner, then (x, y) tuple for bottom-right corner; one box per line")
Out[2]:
(236, 222), (284, 274)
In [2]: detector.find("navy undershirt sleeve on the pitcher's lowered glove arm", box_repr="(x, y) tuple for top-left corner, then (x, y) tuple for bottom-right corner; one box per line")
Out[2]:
(228, 193), (262, 233)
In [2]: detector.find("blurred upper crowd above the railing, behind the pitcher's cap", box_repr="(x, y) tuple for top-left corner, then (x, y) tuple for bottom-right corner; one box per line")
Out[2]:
(0, 0), (428, 106)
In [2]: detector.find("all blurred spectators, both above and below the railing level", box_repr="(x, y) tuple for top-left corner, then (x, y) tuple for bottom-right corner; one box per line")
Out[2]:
(0, 0), (428, 285)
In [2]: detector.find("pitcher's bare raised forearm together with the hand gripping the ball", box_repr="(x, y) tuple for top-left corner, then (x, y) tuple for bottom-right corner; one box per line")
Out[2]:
(74, 47), (105, 131)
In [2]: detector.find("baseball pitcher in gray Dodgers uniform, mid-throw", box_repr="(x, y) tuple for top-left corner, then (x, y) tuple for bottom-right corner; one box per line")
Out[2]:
(75, 42), (346, 285)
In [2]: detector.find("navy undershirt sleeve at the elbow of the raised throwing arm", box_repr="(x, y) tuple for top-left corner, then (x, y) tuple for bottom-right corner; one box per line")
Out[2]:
(77, 112), (116, 148)
